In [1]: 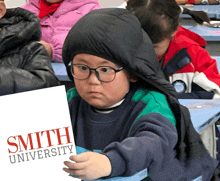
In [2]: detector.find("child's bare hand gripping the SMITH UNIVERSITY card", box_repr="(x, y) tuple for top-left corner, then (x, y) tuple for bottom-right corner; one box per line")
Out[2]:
(63, 152), (112, 180)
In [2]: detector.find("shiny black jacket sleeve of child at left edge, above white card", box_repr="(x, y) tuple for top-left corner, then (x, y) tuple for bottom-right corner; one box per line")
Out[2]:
(0, 42), (60, 95)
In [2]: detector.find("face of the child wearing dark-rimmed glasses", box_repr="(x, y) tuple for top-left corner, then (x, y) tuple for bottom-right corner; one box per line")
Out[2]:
(72, 54), (134, 108)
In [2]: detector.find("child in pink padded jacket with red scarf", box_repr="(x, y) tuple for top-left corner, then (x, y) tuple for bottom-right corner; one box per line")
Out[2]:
(22, 0), (101, 62)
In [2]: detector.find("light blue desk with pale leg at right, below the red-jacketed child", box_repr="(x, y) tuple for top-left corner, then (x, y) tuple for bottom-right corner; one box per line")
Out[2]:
(179, 99), (220, 157)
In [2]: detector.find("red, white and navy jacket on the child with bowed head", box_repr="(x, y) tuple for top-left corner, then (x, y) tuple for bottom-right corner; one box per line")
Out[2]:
(163, 27), (220, 99)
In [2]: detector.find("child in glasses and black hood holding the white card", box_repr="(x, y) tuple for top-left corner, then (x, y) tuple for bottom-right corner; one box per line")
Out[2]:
(63, 8), (218, 181)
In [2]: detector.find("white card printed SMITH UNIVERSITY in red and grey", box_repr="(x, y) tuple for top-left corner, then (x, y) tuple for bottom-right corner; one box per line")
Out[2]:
(0, 86), (79, 181)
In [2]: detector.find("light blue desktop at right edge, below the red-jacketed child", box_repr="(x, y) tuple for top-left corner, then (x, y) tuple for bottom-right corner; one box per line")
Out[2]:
(179, 99), (220, 132)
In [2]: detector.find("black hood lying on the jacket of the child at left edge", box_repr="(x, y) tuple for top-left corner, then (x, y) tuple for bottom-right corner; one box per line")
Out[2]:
(0, 8), (41, 55)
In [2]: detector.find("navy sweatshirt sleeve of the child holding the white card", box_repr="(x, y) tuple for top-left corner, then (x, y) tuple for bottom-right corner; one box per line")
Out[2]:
(103, 113), (192, 181)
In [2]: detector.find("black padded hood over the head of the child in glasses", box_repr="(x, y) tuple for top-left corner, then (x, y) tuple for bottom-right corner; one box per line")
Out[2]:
(62, 8), (175, 95)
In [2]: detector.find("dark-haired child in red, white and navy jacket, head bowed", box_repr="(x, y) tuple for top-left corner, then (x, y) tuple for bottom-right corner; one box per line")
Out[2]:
(127, 0), (220, 99)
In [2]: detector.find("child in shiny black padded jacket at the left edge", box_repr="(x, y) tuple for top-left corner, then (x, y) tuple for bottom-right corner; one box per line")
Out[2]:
(0, 0), (59, 95)
